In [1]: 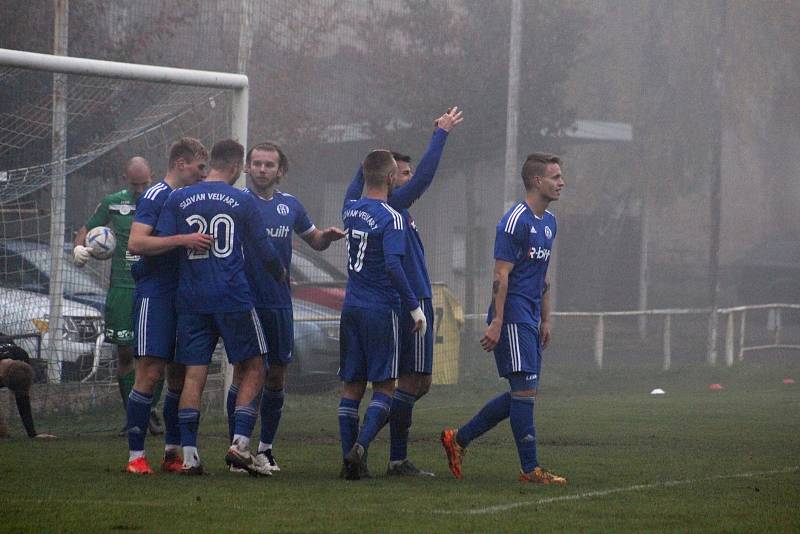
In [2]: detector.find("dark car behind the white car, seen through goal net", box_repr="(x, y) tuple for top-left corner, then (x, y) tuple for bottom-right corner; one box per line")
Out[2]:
(0, 239), (106, 312)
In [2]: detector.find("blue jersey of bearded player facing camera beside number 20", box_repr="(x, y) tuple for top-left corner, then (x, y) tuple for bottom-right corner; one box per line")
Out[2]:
(245, 189), (316, 308)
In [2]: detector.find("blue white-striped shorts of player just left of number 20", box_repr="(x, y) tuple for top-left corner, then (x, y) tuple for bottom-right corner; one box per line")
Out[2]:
(133, 297), (178, 362)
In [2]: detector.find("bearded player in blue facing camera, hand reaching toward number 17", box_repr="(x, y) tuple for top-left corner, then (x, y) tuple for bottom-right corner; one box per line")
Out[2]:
(227, 141), (344, 473)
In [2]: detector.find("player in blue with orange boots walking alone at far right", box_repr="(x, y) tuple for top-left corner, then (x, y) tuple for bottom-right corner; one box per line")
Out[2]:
(441, 153), (567, 485)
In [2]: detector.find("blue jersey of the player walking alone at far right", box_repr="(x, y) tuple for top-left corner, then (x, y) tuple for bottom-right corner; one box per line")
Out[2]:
(486, 202), (556, 328)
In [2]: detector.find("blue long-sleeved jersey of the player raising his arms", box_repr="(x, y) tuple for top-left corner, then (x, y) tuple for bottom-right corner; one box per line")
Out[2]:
(345, 128), (447, 299)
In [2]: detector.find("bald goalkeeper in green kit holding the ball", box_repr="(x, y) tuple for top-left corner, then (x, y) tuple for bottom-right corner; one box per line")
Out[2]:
(73, 157), (163, 435)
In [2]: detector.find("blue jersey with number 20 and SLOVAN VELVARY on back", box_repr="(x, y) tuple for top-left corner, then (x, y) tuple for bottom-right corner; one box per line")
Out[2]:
(157, 181), (277, 314)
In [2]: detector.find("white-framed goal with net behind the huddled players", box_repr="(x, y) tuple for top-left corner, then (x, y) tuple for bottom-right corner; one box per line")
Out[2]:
(0, 51), (247, 431)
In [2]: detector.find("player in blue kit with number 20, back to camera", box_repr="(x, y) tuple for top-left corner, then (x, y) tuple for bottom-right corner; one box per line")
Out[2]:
(156, 139), (285, 475)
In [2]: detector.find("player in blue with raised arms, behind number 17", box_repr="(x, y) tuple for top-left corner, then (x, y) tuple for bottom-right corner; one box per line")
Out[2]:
(345, 107), (463, 476)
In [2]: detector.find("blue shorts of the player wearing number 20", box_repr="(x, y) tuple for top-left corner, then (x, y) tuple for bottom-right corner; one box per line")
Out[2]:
(175, 308), (267, 365)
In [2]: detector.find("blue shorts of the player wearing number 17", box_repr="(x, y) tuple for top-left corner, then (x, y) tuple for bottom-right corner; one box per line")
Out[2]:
(339, 307), (400, 382)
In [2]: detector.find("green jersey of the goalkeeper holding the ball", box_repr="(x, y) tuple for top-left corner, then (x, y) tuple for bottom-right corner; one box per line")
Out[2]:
(86, 189), (139, 288)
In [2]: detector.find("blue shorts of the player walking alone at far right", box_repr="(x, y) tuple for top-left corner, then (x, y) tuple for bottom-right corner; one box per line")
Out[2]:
(494, 323), (542, 383)
